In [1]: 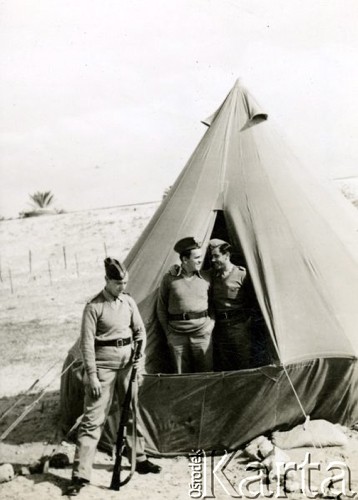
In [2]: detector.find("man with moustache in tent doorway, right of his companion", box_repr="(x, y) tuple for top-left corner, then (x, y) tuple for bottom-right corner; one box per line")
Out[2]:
(209, 239), (251, 370)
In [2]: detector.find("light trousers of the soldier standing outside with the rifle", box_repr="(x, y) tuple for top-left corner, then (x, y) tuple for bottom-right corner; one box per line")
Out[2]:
(72, 367), (146, 481)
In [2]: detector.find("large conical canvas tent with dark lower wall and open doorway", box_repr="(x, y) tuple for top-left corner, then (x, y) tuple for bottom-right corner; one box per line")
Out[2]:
(61, 81), (358, 455)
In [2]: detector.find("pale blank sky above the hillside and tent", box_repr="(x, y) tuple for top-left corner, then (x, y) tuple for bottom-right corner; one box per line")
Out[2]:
(0, 0), (358, 217)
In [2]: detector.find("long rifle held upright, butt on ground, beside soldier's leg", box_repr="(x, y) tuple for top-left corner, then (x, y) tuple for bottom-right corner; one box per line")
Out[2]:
(109, 340), (143, 491)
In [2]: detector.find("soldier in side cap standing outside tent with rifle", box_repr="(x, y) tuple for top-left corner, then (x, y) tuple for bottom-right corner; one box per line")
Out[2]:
(66, 258), (161, 496)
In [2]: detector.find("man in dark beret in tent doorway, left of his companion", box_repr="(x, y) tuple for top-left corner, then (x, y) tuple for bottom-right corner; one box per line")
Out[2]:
(157, 237), (214, 373)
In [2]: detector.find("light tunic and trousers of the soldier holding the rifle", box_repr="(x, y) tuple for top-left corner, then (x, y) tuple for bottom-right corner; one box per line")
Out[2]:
(73, 290), (145, 480)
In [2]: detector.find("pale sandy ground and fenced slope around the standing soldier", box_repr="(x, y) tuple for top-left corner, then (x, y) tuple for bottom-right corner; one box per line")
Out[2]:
(0, 197), (358, 500)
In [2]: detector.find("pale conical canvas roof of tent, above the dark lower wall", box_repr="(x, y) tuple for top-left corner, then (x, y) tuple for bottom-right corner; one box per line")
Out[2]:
(126, 77), (358, 371)
